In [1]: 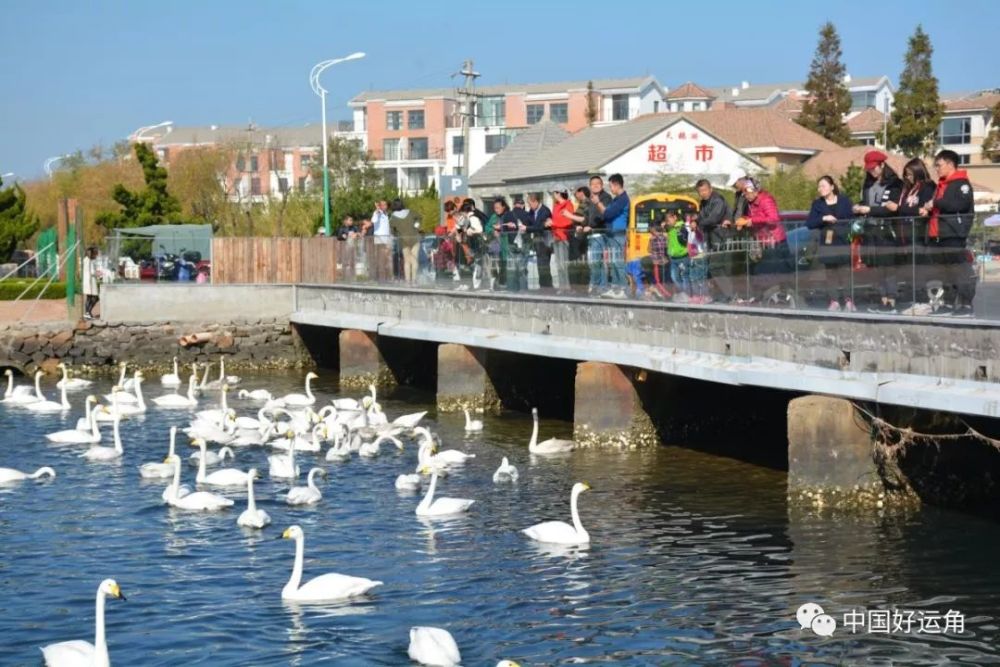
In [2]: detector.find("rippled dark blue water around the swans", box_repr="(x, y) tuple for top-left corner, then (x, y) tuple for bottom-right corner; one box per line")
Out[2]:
(0, 375), (1000, 666)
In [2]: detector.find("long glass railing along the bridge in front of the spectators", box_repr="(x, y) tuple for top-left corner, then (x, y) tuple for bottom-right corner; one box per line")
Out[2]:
(276, 214), (1000, 320)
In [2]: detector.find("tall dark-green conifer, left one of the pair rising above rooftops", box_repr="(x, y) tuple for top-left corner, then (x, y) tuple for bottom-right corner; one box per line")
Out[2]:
(797, 21), (852, 146)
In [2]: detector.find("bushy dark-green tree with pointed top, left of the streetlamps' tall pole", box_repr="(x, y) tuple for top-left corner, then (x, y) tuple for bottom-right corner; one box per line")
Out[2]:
(97, 142), (185, 229)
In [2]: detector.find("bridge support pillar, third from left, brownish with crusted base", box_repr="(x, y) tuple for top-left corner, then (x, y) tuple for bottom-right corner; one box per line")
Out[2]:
(573, 361), (659, 449)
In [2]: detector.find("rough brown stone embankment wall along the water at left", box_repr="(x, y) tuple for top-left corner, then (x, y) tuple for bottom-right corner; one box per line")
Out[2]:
(0, 317), (309, 375)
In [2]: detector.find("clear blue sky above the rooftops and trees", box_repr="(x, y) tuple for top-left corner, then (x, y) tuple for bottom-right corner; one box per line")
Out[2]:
(0, 0), (1000, 179)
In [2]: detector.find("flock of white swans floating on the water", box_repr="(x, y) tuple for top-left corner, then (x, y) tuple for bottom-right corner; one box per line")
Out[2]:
(0, 358), (590, 667)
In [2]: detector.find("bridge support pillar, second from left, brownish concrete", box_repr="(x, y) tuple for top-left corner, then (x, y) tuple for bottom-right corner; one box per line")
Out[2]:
(437, 343), (500, 413)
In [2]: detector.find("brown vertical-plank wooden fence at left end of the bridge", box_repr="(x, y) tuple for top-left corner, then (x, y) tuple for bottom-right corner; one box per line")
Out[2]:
(212, 237), (393, 285)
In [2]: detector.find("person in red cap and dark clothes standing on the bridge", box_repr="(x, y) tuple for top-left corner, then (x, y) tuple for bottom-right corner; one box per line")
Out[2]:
(854, 151), (908, 313)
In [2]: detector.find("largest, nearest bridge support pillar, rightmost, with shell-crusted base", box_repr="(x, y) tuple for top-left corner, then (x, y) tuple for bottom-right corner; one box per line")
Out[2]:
(788, 396), (886, 508)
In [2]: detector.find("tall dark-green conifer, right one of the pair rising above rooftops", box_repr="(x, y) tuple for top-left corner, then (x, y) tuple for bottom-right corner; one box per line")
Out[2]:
(889, 25), (944, 155)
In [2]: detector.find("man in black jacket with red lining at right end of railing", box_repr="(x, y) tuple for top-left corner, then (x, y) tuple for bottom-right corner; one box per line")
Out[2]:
(920, 149), (976, 315)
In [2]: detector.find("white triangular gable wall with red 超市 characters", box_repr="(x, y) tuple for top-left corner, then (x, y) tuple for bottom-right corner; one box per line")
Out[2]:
(601, 120), (759, 181)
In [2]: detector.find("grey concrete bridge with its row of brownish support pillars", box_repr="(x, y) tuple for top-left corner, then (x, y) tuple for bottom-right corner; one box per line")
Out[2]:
(99, 285), (1000, 512)
